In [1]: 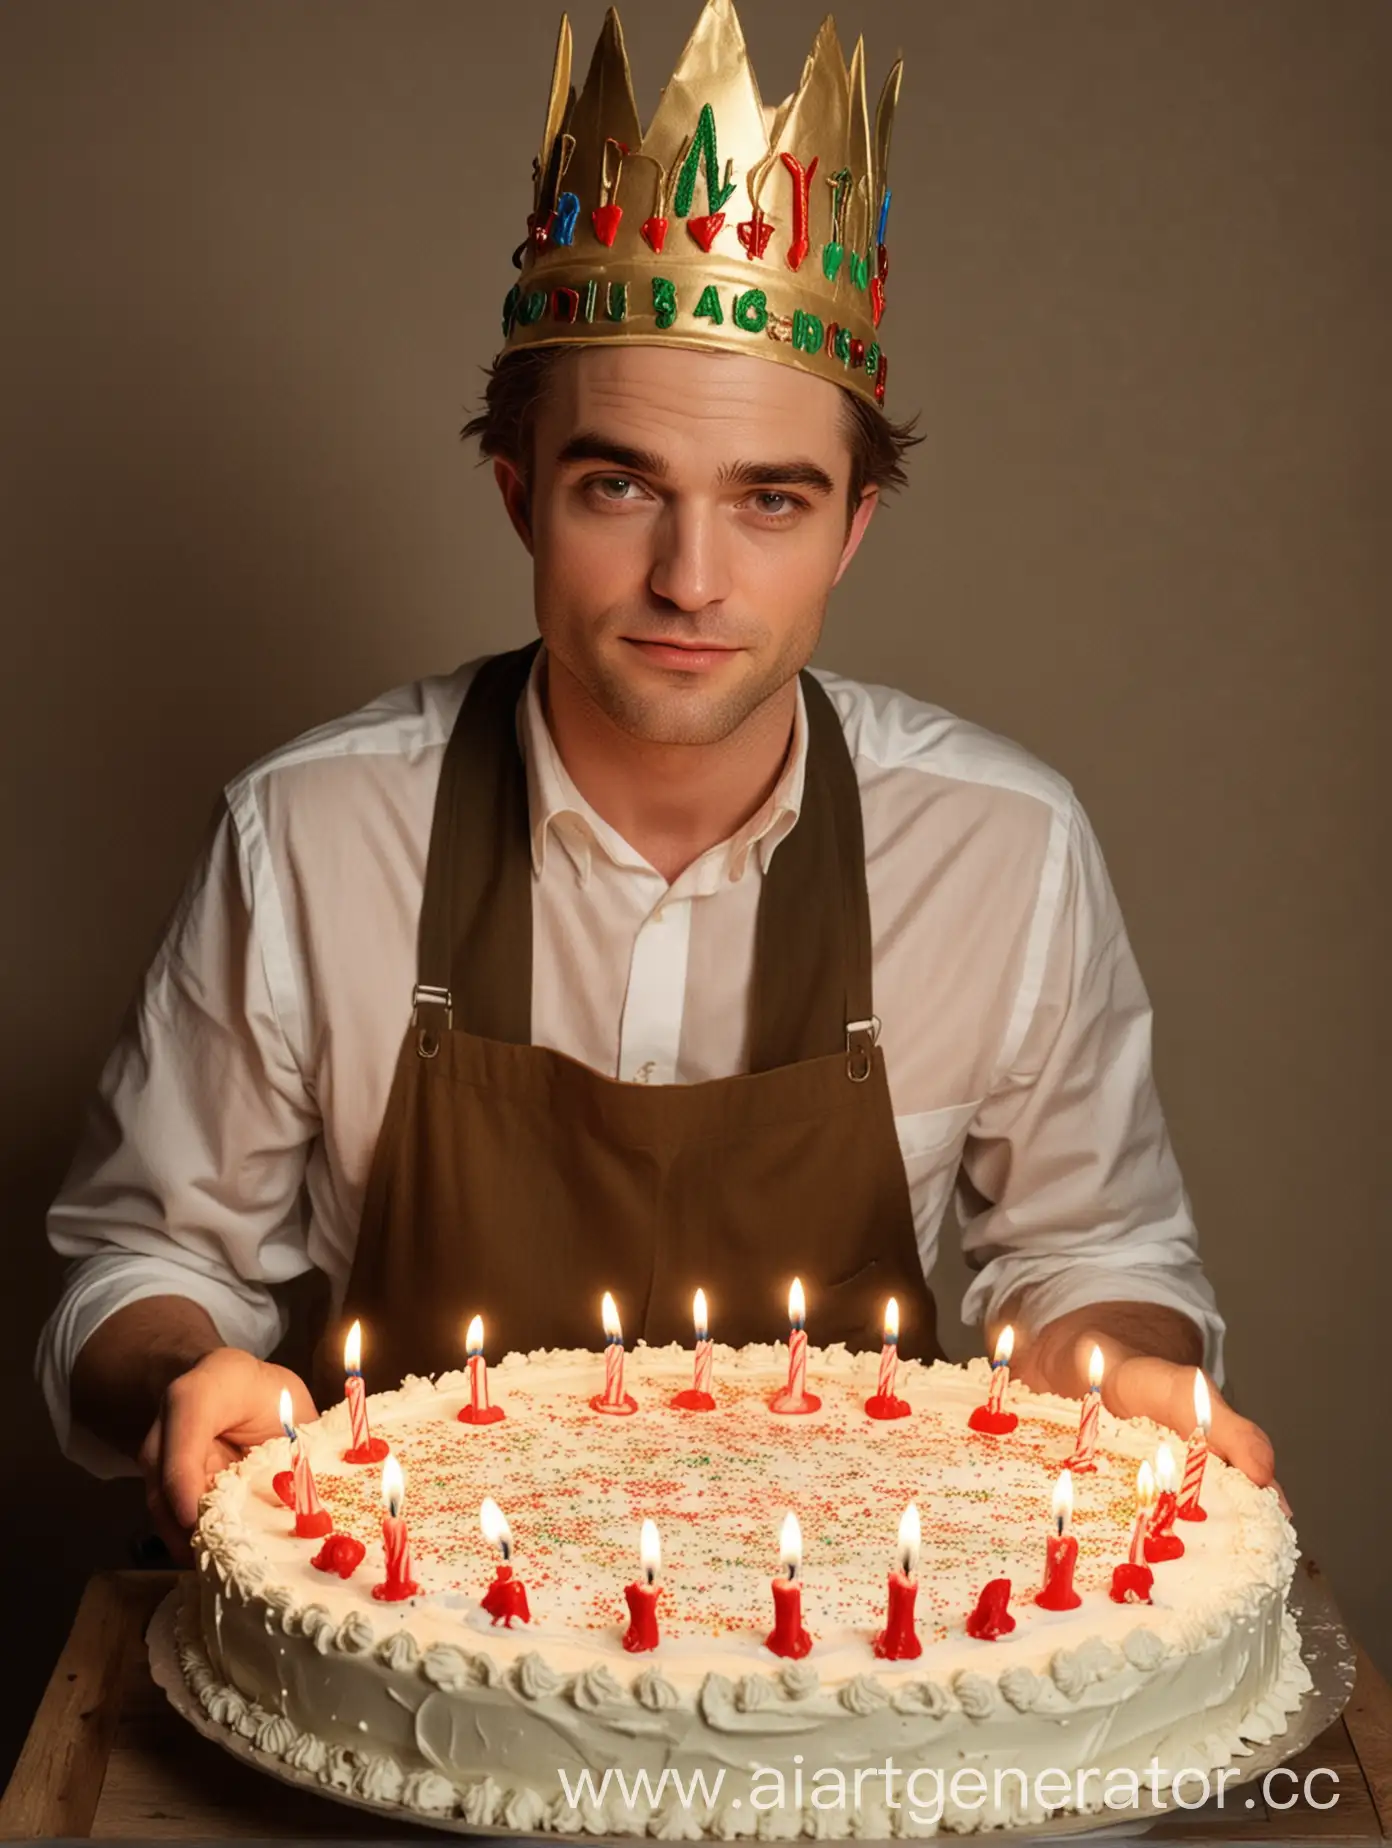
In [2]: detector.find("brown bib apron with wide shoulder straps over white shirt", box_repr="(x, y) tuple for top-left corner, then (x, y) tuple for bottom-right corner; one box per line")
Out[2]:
(320, 643), (941, 1403)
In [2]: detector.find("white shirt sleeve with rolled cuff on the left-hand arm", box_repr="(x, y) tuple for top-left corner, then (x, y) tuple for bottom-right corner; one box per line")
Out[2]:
(35, 804), (320, 1477)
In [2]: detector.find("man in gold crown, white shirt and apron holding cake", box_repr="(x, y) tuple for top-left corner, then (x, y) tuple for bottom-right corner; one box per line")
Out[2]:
(41, 0), (1272, 1549)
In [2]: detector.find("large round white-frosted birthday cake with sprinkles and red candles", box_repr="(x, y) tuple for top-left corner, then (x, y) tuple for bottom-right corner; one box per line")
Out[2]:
(179, 1343), (1309, 1839)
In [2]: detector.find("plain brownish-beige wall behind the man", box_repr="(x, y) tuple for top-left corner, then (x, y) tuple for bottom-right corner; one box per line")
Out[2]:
(0, 0), (1392, 1766)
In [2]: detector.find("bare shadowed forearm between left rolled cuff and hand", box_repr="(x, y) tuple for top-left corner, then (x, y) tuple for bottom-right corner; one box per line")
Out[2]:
(70, 1295), (222, 1456)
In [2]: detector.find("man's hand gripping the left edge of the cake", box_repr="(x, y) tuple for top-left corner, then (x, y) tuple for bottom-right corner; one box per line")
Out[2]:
(137, 1347), (318, 1565)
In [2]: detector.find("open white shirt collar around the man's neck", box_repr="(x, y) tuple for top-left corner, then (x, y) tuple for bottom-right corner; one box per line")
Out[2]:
(518, 649), (808, 891)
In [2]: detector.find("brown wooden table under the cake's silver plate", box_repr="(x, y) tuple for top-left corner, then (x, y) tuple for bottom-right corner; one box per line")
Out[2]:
(0, 1573), (1392, 1842)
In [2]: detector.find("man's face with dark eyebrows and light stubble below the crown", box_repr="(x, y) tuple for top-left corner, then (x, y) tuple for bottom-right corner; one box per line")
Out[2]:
(497, 346), (874, 745)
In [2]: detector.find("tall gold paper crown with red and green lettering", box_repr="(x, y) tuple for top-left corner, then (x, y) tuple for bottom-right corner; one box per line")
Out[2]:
(503, 0), (902, 405)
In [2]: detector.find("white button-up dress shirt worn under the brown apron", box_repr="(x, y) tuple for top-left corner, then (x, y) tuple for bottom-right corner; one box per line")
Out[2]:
(39, 656), (1224, 1475)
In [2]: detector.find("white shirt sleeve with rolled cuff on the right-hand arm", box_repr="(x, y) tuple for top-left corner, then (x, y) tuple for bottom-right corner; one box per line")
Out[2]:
(958, 802), (1224, 1382)
